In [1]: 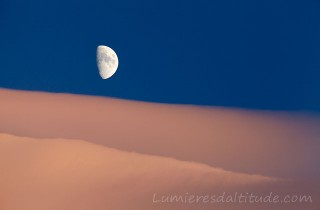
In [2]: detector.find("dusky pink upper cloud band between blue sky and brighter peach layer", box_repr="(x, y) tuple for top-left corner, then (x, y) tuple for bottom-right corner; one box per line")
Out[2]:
(0, 89), (320, 178)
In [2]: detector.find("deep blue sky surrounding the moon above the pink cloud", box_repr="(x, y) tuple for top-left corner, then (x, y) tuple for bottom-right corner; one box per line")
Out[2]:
(0, 0), (320, 111)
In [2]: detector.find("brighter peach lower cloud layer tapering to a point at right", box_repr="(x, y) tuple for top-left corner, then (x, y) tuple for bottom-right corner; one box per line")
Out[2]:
(0, 134), (276, 210)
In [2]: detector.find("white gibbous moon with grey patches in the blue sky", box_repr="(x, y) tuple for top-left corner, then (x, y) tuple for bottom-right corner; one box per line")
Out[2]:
(97, 45), (119, 79)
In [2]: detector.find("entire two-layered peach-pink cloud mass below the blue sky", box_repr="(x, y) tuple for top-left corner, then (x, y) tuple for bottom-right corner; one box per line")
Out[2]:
(0, 89), (320, 210)
